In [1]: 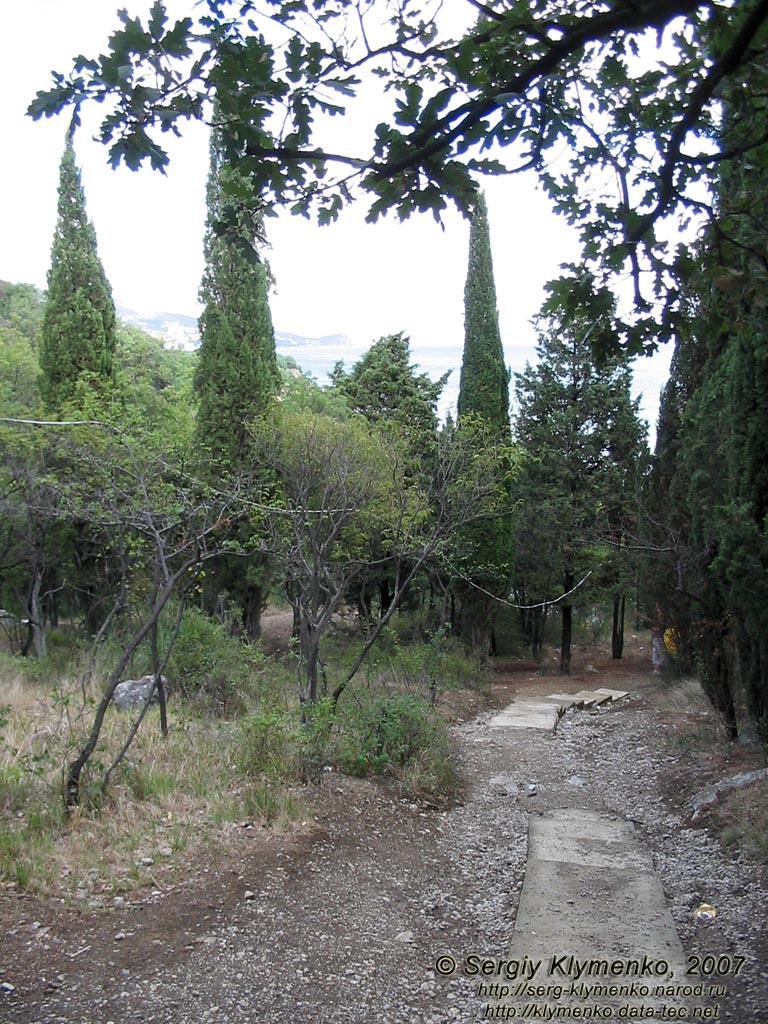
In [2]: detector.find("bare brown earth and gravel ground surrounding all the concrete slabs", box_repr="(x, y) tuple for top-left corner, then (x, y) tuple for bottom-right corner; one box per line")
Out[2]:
(0, 618), (768, 1024)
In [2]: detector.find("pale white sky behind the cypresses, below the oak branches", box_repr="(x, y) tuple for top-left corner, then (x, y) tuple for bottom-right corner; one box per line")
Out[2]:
(0, 0), (671, 428)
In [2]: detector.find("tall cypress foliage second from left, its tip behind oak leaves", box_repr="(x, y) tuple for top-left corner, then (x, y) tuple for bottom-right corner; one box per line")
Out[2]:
(195, 132), (280, 471)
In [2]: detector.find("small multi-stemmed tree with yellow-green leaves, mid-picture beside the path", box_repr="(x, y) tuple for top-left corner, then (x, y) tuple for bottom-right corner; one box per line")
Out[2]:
(247, 387), (508, 703)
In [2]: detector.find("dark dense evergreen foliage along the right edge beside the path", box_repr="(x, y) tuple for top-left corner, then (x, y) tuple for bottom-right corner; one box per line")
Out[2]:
(653, 51), (768, 737)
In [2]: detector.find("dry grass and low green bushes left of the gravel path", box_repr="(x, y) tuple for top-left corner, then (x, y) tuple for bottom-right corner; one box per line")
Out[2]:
(0, 621), (482, 898)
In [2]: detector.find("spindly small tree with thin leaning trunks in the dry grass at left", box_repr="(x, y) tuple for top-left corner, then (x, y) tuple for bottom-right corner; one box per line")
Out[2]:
(55, 424), (242, 807)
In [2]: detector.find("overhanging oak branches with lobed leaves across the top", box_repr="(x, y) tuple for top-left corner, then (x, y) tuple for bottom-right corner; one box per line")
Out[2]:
(30, 0), (768, 352)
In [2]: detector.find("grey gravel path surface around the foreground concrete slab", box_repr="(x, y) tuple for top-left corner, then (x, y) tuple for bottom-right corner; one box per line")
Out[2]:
(0, 675), (768, 1024)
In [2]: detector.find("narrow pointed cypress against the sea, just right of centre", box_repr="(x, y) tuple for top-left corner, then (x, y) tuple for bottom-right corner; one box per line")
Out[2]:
(455, 195), (512, 653)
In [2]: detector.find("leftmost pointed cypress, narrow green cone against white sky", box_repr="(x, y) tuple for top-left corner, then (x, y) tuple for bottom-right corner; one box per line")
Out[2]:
(40, 129), (117, 413)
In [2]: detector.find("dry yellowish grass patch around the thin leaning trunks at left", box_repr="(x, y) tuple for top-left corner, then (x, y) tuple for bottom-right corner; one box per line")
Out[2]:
(0, 657), (306, 901)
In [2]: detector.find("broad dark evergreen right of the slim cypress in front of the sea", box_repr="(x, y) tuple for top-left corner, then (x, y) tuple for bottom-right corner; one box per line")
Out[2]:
(515, 323), (645, 674)
